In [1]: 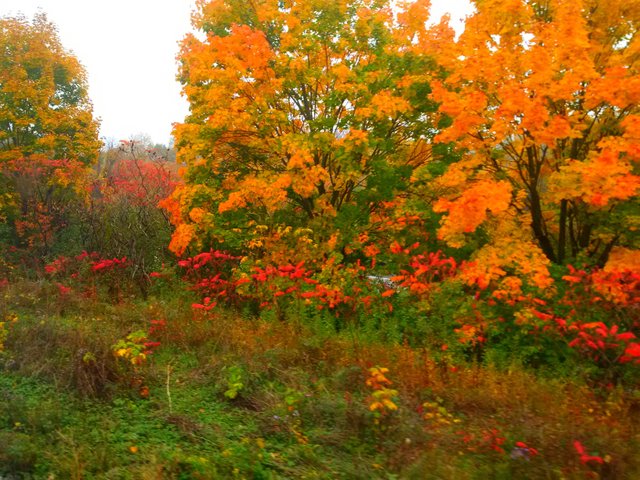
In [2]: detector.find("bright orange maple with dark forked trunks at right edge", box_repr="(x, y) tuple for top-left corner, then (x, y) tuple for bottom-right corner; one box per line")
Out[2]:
(424, 0), (640, 265)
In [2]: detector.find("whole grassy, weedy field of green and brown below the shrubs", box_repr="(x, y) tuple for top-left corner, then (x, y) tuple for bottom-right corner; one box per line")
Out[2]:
(0, 289), (640, 479)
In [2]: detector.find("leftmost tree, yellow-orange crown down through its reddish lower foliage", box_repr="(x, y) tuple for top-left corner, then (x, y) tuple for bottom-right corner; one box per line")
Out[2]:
(0, 15), (100, 254)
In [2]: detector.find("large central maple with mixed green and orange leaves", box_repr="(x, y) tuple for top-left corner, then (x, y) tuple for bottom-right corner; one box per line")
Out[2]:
(165, 0), (434, 262)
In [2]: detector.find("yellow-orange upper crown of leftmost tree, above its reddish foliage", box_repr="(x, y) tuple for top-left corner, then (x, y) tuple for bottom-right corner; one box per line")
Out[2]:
(0, 14), (100, 163)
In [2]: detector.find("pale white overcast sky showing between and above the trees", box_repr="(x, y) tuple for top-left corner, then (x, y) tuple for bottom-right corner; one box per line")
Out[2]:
(0, 0), (470, 144)
